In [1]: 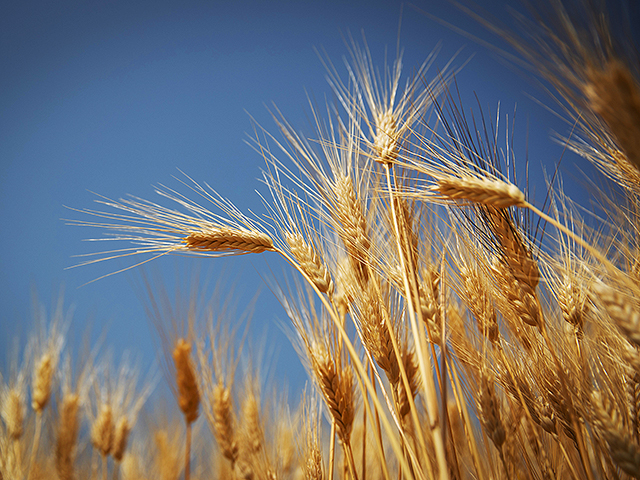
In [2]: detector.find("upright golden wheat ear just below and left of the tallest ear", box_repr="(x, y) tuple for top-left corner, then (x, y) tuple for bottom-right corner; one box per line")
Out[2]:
(334, 176), (371, 284)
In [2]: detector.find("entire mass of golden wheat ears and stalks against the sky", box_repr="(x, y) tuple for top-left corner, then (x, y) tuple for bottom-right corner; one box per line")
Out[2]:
(0, 2), (640, 480)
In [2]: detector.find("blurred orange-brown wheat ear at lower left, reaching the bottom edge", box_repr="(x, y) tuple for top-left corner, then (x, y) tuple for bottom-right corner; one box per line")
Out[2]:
(55, 393), (80, 480)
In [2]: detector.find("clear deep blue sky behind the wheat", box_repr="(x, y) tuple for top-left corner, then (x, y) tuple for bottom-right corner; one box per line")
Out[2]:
(0, 0), (583, 394)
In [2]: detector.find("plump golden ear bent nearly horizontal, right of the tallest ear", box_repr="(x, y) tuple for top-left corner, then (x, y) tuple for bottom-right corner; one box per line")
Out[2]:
(435, 177), (525, 208)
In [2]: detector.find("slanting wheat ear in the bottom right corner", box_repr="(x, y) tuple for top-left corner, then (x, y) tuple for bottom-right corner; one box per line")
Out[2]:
(591, 391), (640, 478)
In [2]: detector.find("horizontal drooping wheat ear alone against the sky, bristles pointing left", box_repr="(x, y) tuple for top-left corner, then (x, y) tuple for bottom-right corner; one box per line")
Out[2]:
(183, 227), (274, 253)
